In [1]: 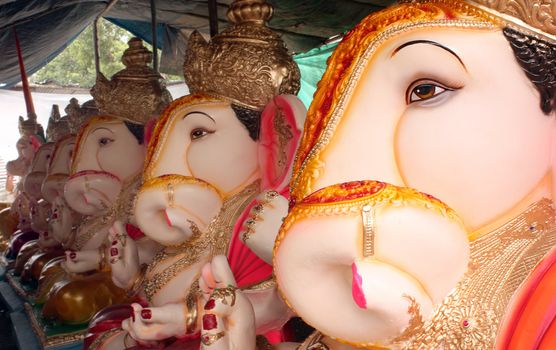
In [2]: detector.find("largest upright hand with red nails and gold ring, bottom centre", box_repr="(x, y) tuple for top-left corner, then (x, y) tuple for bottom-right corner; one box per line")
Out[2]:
(199, 255), (256, 350)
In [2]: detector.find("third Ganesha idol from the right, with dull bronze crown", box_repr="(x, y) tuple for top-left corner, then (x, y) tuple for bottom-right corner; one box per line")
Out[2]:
(39, 38), (171, 324)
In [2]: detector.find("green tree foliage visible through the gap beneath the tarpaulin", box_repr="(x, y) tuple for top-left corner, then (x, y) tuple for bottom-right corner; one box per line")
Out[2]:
(31, 19), (131, 87)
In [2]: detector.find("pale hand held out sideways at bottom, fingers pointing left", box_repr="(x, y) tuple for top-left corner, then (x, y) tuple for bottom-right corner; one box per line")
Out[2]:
(122, 303), (189, 346)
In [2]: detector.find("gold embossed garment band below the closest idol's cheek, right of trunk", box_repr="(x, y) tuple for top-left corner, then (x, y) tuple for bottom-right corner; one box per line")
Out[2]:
(400, 199), (556, 350)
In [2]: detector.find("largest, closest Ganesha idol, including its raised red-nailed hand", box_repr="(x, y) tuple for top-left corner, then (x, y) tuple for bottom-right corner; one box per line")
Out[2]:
(198, 0), (556, 350)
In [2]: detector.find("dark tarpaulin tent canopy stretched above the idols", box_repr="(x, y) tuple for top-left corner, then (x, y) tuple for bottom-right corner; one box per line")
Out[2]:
(0, 0), (392, 87)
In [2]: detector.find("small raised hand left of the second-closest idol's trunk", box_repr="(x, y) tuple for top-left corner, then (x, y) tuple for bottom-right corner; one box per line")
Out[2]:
(108, 220), (141, 290)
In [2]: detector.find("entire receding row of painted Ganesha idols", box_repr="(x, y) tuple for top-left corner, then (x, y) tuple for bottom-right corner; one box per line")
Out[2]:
(3, 0), (556, 350)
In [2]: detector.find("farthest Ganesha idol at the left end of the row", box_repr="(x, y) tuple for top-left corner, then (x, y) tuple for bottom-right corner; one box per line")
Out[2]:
(0, 115), (44, 260)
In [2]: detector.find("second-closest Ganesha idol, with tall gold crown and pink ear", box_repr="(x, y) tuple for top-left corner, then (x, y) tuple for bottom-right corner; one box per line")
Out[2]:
(85, 1), (306, 349)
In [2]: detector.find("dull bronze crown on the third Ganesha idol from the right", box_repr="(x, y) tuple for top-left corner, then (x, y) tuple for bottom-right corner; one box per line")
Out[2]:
(91, 38), (172, 124)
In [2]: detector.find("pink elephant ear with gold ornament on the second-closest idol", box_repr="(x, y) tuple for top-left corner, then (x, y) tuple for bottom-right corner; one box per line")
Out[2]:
(259, 95), (307, 193)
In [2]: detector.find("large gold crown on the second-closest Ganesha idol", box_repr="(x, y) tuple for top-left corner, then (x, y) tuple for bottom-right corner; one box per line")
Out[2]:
(183, 0), (300, 110)
